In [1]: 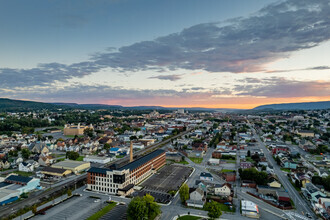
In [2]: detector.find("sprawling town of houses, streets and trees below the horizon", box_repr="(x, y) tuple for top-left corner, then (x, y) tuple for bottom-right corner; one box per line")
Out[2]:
(0, 109), (330, 219)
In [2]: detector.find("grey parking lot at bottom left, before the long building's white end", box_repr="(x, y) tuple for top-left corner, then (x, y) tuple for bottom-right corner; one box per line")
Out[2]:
(32, 196), (106, 220)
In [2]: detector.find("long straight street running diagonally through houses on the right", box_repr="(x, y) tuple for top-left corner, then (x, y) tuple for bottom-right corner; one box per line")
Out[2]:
(249, 124), (317, 219)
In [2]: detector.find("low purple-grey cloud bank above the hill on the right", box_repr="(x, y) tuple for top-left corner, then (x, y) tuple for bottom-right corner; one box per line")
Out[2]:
(233, 77), (330, 98)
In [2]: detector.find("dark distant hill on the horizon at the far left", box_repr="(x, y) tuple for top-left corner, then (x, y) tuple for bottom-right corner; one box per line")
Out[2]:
(0, 98), (67, 112)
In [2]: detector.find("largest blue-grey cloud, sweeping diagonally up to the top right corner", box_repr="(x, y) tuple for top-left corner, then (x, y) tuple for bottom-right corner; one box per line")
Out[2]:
(0, 0), (330, 88)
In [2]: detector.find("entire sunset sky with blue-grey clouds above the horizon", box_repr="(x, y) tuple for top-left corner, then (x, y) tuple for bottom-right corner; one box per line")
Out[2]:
(0, 0), (330, 109)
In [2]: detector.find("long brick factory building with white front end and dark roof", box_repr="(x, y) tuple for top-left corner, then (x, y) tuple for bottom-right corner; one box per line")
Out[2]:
(87, 149), (166, 195)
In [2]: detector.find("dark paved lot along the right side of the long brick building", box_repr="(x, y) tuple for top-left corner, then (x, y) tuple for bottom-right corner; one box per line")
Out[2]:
(141, 164), (192, 192)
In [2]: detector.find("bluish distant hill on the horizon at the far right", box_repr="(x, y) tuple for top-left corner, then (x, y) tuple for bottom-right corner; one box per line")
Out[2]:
(253, 101), (330, 110)
